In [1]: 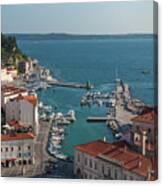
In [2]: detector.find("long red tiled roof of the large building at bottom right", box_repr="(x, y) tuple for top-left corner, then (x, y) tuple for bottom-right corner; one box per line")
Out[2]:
(75, 140), (156, 177)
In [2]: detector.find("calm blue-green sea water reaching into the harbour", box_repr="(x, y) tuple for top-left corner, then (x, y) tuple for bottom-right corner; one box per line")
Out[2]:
(18, 37), (154, 155)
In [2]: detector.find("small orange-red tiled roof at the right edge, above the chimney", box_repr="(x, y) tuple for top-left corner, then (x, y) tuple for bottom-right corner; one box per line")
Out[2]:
(131, 111), (157, 124)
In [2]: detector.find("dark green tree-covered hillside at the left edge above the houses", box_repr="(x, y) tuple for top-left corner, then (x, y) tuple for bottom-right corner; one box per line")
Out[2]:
(1, 34), (27, 66)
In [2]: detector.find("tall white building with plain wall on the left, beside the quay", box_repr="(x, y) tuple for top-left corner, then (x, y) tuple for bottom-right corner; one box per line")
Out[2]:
(6, 95), (39, 134)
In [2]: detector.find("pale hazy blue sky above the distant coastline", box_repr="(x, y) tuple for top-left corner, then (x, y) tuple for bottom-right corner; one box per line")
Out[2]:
(1, 1), (153, 34)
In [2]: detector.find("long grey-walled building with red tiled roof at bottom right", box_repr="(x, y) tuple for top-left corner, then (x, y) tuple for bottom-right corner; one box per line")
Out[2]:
(74, 140), (156, 180)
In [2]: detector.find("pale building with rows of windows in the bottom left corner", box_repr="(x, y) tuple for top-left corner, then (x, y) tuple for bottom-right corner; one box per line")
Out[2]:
(1, 132), (35, 168)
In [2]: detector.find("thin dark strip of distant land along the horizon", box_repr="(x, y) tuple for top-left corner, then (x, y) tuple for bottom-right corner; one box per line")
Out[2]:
(6, 33), (157, 40)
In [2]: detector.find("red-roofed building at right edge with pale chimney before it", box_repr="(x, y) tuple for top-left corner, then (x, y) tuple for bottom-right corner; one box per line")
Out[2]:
(130, 109), (157, 157)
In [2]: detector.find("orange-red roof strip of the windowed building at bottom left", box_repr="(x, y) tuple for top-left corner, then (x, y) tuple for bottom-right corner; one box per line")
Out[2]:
(1, 132), (35, 141)
